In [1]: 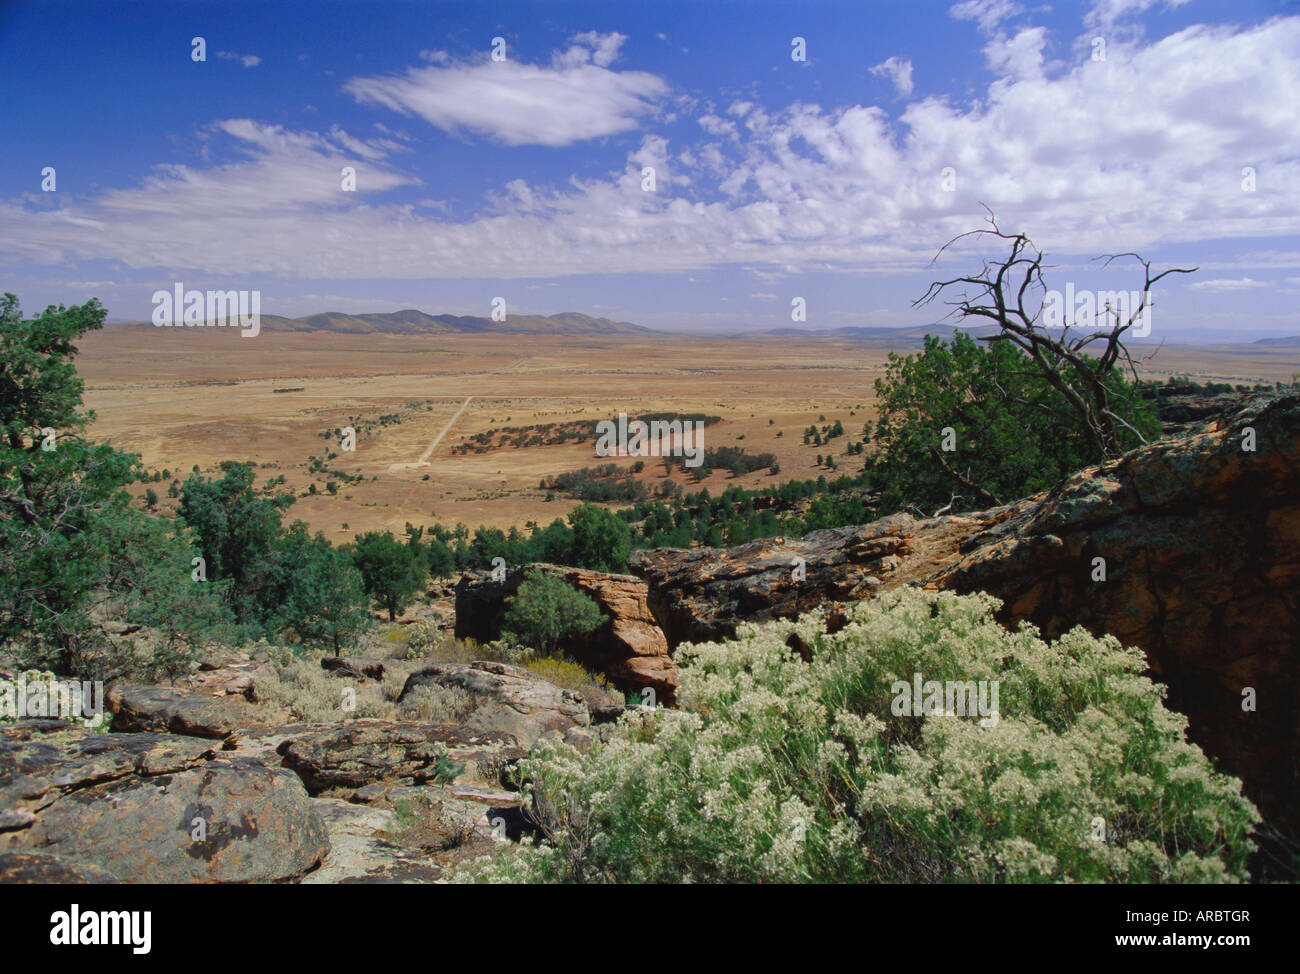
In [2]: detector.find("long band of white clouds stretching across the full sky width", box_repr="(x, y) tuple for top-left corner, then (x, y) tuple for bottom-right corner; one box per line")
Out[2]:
(0, 18), (1300, 291)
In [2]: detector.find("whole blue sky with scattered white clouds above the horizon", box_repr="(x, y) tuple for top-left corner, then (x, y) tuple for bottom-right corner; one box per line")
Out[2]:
(0, 0), (1300, 342)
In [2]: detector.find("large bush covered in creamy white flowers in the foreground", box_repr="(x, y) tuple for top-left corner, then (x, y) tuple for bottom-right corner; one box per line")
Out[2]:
(458, 589), (1258, 883)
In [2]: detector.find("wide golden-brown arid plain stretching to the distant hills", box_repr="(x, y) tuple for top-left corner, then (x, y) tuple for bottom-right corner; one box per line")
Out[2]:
(77, 325), (1300, 542)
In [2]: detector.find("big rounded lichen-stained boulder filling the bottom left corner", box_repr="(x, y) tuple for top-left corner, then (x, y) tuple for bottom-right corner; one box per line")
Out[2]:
(0, 731), (329, 883)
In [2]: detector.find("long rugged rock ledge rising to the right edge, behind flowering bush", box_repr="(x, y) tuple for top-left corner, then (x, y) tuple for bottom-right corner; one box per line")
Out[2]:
(631, 395), (1300, 836)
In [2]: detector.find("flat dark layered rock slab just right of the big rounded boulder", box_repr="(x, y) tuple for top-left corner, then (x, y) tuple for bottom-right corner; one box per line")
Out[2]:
(278, 720), (524, 795)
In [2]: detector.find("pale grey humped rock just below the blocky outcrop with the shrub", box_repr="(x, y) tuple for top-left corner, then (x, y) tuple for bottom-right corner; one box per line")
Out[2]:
(398, 661), (590, 748)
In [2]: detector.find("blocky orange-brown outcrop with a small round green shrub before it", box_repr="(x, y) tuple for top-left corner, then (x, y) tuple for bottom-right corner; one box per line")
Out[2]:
(456, 564), (681, 705)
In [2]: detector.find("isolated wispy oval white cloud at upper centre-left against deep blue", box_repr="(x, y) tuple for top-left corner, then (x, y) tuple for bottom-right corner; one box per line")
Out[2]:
(343, 31), (668, 146)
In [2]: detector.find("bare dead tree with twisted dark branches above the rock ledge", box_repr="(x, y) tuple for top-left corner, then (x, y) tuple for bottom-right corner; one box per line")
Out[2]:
(913, 207), (1199, 459)
